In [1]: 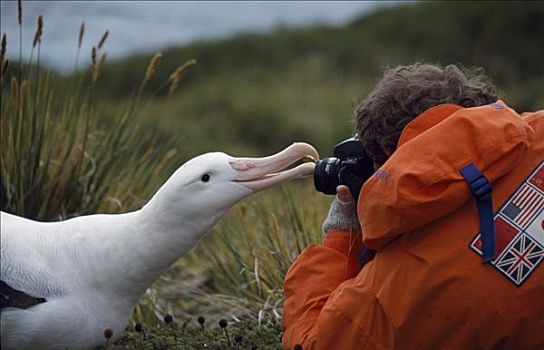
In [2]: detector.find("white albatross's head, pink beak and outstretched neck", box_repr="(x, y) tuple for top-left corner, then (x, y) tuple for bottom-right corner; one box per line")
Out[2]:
(112, 143), (319, 302)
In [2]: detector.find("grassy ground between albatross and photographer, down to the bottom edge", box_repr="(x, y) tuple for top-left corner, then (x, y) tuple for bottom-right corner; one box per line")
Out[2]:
(113, 180), (324, 349)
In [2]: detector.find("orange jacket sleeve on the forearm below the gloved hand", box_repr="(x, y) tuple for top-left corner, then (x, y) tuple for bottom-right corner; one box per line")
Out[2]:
(283, 231), (362, 349)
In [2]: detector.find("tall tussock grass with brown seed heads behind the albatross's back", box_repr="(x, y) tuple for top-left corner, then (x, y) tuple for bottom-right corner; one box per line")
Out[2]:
(0, 6), (196, 220)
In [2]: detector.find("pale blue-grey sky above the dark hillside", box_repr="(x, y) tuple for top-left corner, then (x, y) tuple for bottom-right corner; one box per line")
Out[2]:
(0, 0), (404, 70)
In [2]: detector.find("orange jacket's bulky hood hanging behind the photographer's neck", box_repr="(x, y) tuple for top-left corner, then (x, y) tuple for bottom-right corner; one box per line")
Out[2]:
(358, 100), (535, 250)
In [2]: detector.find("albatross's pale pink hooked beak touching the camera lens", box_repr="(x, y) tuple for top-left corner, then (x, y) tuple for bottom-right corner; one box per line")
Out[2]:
(229, 142), (319, 192)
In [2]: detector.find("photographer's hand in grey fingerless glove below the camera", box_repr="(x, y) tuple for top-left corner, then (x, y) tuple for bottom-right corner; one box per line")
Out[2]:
(323, 185), (359, 233)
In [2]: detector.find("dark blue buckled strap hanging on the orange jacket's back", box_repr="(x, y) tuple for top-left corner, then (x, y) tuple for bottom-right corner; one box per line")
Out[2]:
(460, 163), (497, 263)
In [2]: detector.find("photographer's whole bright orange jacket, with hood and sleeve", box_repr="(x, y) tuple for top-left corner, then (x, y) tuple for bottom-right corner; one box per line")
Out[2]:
(283, 101), (544, 350)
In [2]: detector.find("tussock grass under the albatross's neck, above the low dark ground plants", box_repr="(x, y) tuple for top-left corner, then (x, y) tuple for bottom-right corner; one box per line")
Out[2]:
(133, 179), (331, 325)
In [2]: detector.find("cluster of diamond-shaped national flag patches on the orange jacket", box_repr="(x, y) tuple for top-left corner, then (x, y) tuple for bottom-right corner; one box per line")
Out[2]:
(470, 161), (544, 287)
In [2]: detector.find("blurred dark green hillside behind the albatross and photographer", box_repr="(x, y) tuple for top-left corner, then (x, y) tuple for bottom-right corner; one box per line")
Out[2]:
(88, 1), (544, 160)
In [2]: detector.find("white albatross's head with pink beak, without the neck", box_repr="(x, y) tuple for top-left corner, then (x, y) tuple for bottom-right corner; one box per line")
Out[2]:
(143, 143), (319, 231)
